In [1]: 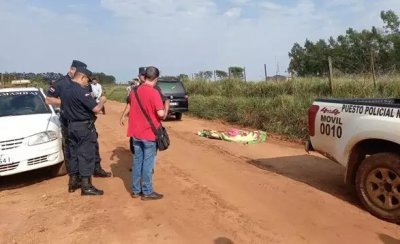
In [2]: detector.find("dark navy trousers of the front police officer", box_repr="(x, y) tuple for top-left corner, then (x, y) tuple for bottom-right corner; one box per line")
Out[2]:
(68, 122), (98, 177)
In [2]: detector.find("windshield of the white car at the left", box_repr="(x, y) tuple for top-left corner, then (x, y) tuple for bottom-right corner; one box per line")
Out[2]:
(0, 91), (50, 117)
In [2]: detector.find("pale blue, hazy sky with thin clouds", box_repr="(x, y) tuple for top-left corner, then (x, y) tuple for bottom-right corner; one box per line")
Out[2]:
(0, 0), (400, 82)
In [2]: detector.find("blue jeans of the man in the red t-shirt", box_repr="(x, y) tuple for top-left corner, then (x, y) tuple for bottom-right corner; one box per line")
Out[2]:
(132, 138), (157, 195)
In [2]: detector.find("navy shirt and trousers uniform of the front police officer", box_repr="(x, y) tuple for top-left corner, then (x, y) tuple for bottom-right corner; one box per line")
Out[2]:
(61, 82), (98, 177)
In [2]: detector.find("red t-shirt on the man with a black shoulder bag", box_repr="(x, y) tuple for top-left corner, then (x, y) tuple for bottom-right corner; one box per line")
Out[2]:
(128, 84), (164, 141)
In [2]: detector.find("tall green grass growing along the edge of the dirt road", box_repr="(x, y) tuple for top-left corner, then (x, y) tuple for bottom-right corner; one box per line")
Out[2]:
(102, 76), (400, 139)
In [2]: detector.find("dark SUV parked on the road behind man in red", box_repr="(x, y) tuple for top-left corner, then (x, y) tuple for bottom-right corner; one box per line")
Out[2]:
(157, 78), (189, 120)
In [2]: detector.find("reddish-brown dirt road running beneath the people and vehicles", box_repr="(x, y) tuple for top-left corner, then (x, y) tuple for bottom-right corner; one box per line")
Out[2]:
(0, 102), (400, 244)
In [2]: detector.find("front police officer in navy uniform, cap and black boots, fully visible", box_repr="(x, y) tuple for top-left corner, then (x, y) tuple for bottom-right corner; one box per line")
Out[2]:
(61, 66), (106, 195)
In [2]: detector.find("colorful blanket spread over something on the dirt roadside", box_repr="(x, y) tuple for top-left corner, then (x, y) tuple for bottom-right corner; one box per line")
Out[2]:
(197, 129), (267, 144)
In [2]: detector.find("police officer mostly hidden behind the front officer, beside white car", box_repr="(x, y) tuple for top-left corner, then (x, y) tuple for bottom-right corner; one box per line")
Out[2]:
(46, 60), (111, 180)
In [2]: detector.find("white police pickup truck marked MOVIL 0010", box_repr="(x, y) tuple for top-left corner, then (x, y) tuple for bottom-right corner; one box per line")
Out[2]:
(306, 99), (400, 223)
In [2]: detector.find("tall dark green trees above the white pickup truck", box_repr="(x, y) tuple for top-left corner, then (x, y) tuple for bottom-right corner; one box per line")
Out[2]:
(288, 10), (400, 76)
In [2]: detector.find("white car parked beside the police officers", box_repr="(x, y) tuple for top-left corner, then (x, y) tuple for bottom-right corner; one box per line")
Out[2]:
(0, 88), (66, 176)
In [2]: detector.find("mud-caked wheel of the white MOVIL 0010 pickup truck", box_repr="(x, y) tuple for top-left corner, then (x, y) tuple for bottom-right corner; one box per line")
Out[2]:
(356, 153), (400, 223)
